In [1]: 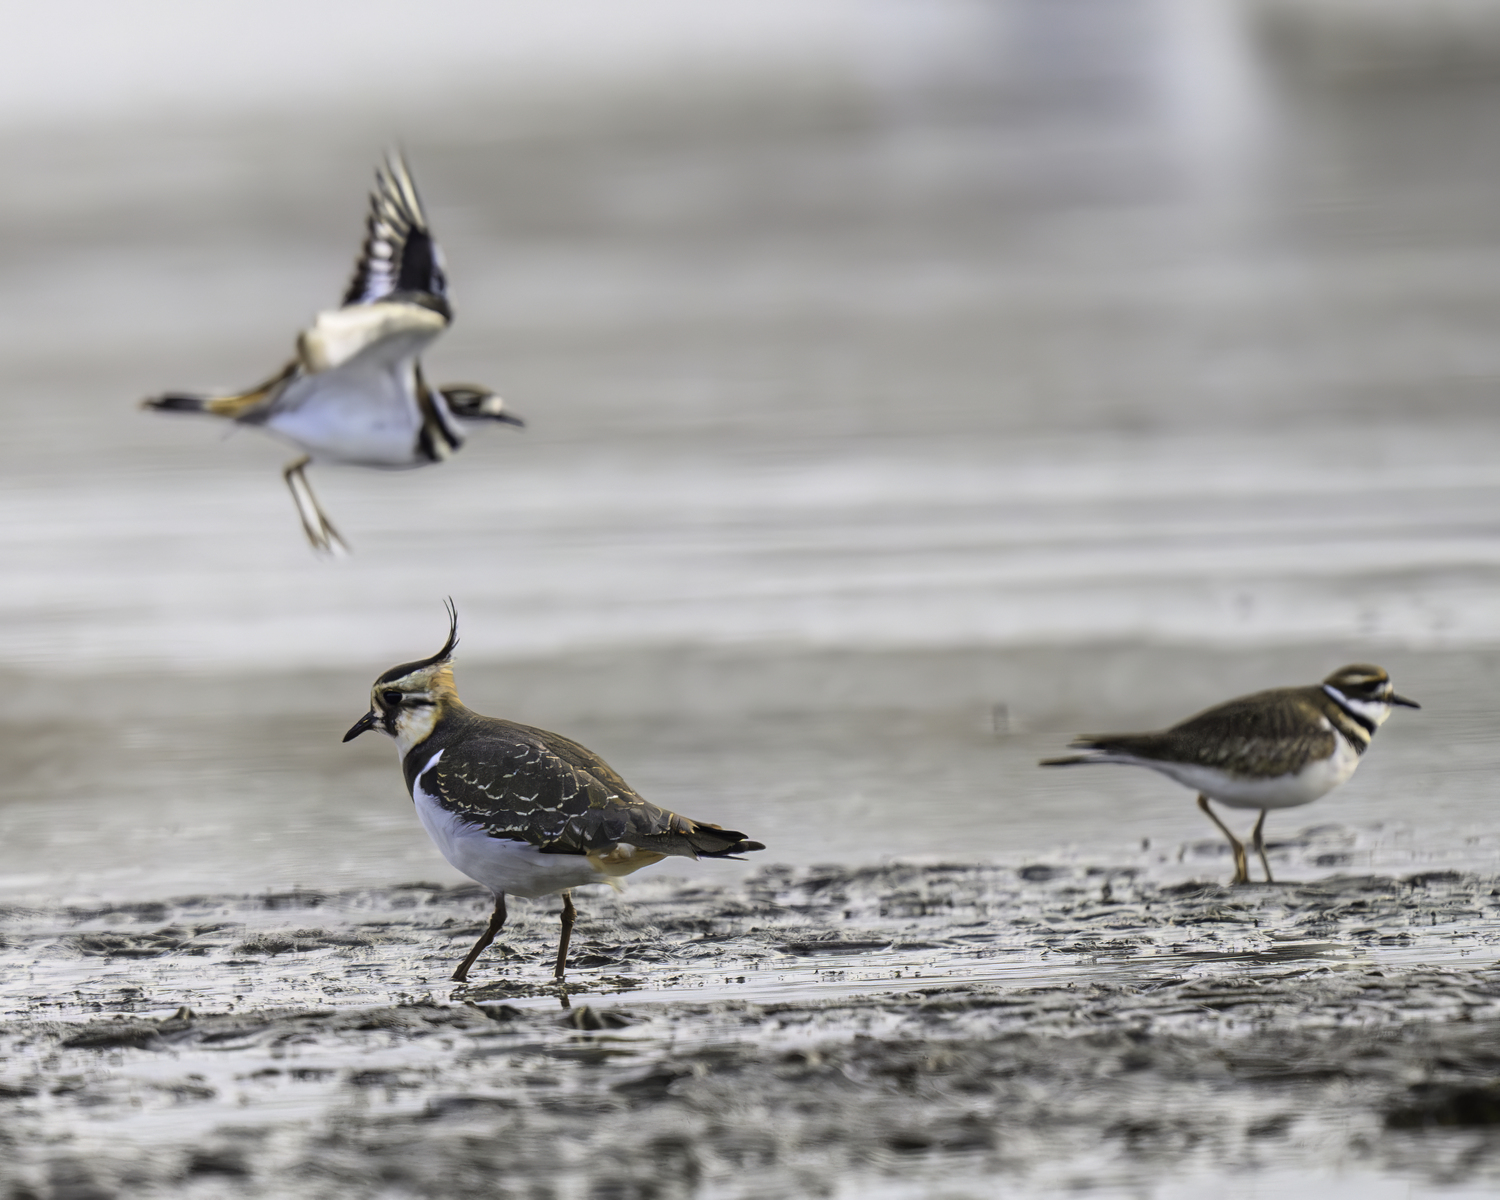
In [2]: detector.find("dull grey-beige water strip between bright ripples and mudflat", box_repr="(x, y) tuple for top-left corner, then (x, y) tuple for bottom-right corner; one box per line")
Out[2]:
(0, 636), (1500, 902)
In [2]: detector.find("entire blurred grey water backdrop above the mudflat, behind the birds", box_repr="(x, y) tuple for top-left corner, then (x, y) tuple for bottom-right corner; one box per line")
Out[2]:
(0, 0), (1500, 897)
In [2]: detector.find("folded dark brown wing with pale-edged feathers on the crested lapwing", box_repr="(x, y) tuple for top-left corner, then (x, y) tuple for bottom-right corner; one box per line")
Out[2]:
(413, 722), (759, 858)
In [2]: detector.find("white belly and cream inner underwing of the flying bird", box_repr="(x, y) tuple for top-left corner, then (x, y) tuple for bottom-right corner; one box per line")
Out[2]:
(266, 300), (447, 468)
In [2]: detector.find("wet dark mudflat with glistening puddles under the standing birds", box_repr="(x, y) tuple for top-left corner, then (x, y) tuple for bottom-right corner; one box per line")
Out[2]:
(0, 852), (1500, 1200)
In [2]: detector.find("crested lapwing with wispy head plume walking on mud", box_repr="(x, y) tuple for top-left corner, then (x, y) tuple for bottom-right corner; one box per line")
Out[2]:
(344, 602), (765, 983)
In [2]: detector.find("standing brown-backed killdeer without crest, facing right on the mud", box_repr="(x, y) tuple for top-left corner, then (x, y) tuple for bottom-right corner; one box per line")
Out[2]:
(1041, 663), (1421, 884)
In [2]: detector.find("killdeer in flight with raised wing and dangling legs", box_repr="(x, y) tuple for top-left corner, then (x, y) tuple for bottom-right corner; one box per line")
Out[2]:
(143, 155), (522, 554)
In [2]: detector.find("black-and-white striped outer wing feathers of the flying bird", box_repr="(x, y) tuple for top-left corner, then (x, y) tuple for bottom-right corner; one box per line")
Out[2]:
(344, 152), (450, 317)
